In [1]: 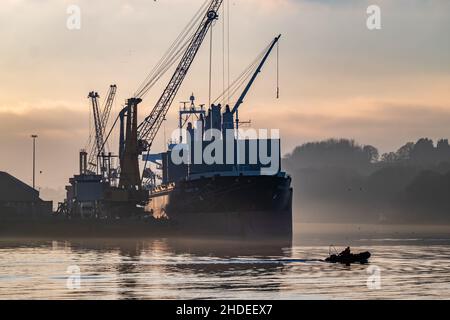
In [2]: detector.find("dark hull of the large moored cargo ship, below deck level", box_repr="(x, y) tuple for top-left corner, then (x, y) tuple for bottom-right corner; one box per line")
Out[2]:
(149, 175), (292, 240)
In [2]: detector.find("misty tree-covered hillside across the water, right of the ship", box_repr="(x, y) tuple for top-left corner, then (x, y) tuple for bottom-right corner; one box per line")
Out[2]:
(283, 138), (450, 224)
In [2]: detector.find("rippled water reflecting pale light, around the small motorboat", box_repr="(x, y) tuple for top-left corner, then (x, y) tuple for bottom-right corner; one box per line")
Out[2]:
(0, 239), (450, 299)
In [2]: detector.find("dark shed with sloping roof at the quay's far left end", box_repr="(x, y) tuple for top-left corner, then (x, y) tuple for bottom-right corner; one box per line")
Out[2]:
(0, 171), (53, 218)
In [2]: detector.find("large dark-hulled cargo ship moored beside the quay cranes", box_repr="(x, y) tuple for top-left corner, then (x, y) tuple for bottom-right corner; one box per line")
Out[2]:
(146, 97), (292, 238)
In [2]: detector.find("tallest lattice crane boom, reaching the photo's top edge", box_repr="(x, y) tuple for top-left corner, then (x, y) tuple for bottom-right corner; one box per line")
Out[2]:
(137, 0), (223, 151)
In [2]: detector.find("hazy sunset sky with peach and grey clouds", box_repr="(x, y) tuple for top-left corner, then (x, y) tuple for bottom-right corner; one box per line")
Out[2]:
(0, 0), (450, 196)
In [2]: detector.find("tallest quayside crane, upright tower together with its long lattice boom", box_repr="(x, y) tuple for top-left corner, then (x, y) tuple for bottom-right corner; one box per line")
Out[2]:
(119, 0), (223, 190)
